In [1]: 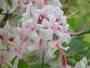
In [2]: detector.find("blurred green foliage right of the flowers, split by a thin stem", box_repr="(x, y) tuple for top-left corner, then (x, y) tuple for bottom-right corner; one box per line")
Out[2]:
(61, 0), (90, 65)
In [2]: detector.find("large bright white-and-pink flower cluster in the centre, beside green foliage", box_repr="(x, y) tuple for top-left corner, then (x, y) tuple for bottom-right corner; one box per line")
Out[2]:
(18, 0), (71, 57)
